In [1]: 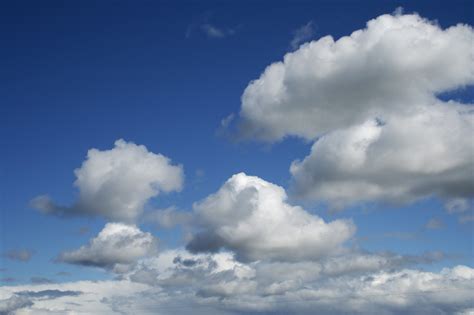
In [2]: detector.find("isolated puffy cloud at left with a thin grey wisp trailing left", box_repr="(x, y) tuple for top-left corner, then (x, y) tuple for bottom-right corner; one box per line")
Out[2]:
(32, 140), (184, 223)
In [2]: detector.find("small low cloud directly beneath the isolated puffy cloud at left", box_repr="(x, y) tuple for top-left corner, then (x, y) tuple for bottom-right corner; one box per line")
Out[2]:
(58, 223), (157, 273)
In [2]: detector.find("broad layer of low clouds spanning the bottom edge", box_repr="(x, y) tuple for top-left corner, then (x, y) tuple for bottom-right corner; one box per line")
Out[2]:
(0, 249), (474, 315)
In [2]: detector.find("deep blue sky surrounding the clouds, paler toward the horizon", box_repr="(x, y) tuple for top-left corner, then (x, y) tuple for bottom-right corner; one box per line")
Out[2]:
(0, 1), (474, 314)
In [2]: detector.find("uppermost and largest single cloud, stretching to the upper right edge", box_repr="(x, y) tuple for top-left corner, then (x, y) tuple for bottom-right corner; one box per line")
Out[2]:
(240, 14), (474, 141)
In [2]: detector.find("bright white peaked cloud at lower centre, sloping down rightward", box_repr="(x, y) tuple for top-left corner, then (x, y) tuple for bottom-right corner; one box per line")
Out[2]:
(188, 173), (355, 261)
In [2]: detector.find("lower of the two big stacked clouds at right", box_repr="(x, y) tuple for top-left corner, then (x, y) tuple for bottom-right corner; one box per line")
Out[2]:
(290, 103), (474, 205)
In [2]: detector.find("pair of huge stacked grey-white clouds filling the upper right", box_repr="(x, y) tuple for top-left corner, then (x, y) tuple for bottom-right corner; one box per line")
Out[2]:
(234, 14), (474, 205)
